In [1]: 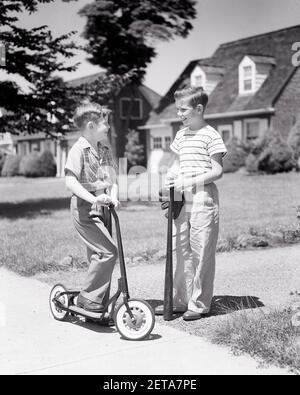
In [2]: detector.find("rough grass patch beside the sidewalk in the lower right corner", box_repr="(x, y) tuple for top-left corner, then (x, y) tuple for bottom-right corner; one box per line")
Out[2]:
(210, 308), (300, 374)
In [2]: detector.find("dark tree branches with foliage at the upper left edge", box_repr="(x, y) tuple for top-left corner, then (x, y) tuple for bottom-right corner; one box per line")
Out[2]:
(0, 0), (79, 133)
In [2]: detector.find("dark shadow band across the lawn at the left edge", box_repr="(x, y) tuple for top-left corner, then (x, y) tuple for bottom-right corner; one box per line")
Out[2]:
(0, 197), (70, 219)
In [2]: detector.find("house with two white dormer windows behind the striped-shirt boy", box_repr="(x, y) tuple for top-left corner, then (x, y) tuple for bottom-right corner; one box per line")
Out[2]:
(141, 25), (300, 172)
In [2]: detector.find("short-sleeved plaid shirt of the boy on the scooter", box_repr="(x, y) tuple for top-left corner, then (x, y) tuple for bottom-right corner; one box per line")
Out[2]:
(65, 137), (116, 192)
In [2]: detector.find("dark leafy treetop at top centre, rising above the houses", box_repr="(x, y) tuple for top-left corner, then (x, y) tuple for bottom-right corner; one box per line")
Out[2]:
(79, 0), (196, 81)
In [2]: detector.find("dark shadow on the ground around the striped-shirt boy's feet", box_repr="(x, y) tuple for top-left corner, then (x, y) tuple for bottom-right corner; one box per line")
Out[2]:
(147, 295), (265, 319)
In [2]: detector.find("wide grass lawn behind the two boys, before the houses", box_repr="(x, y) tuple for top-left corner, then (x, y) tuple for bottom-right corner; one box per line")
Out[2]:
(0, 173), (300, 275)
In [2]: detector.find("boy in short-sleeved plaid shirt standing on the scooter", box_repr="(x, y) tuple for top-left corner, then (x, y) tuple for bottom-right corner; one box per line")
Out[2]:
(65, 103), (119, 312)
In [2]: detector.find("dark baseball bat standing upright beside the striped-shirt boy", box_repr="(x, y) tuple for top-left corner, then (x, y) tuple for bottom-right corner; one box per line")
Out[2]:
(164, 188), (174, 321)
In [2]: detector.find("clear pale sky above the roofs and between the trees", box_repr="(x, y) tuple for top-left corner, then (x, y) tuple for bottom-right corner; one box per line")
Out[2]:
(2, 0), (300, 95)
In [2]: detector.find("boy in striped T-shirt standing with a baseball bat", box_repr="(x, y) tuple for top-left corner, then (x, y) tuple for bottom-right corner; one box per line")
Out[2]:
(158, 88), (227, 321)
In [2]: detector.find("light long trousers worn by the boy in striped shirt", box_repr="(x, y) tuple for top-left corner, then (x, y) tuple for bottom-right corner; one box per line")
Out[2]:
(173, 183), (219, 314)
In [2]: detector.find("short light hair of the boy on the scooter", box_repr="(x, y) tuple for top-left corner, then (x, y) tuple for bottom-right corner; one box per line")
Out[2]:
(73, 101), (110, 129)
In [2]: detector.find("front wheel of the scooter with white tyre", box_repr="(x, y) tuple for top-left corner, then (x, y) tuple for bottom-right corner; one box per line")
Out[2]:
(114, 299), (155, 340)
